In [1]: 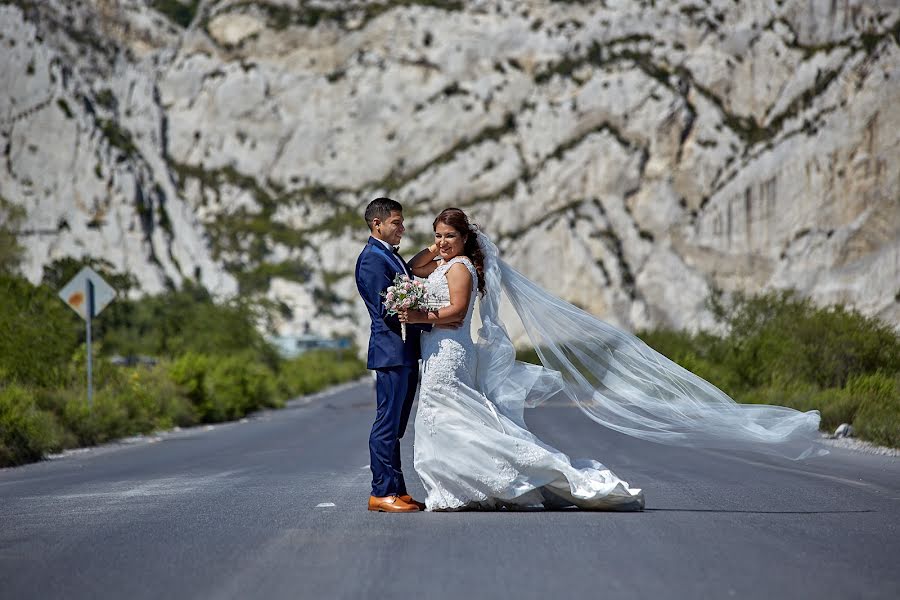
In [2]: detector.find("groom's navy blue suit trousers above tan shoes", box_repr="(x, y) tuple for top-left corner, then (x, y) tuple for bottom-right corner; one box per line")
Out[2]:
(369, 366), (419, 497)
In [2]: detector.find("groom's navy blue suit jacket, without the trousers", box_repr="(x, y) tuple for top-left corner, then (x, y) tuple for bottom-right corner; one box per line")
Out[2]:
(356, 237), (431, 369)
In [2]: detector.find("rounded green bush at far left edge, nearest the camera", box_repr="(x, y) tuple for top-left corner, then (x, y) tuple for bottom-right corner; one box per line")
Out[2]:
(0, 385), (61, 466)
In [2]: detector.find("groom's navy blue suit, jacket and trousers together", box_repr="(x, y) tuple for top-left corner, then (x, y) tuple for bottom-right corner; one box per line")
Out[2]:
(356, 237), (423, 497)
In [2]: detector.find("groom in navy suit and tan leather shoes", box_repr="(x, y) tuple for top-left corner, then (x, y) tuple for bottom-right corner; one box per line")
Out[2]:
(356, 198), (442, 512)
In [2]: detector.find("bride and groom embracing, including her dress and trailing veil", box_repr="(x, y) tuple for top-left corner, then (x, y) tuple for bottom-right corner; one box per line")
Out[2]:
(356, 198), (822, 512)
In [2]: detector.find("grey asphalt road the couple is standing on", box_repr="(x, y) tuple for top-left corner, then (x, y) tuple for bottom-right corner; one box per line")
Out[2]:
(0, 384), (900, 600)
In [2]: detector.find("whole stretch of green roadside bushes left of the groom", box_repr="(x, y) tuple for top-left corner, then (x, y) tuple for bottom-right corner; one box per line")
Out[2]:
(0, 255), (364, 466)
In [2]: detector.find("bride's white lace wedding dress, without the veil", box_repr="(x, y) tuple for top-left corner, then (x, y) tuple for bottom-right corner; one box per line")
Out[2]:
(415, 257), (644, 511)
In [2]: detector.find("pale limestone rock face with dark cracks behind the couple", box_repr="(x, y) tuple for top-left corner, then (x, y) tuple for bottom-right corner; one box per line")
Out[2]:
(0, 0), (900, 338)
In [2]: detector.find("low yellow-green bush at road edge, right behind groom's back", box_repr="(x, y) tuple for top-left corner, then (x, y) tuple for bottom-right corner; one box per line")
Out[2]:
(278, 349), (366, 397)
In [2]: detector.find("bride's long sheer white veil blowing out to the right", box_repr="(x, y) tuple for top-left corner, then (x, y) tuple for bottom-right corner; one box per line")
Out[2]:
(475, 231), (827, 459)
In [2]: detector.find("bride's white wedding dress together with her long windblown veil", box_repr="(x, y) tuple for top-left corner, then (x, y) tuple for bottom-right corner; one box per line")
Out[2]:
(415, 231), (827, 510)
